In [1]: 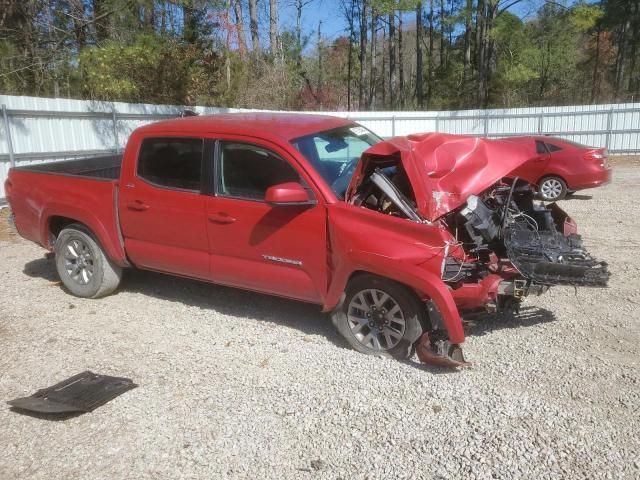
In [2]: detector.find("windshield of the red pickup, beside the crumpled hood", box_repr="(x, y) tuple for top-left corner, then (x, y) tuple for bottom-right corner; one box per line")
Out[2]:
(291, 124), (382, 199)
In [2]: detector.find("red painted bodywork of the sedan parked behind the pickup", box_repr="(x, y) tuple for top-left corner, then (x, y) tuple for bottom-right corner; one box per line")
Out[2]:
(505, 136), (611, 190)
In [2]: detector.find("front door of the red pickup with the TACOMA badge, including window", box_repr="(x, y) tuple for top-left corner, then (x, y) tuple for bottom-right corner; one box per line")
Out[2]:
(206, 139), (327, 303)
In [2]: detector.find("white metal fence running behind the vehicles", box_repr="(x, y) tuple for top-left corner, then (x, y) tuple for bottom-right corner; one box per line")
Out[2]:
(0, 95), (640, 201)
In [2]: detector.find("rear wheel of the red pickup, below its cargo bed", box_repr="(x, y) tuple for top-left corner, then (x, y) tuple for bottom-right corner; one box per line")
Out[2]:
(54, 223), (122, 298)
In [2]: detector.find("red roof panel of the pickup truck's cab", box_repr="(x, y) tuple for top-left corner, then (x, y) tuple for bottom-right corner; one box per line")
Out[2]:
(138, 112), (354, 141)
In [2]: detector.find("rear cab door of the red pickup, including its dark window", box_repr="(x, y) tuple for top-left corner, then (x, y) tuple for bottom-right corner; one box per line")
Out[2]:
(120, 136), (210, 279)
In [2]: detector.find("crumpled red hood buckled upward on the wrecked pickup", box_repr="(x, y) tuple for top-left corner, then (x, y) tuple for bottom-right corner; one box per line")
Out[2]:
(346, 133), (535, 221)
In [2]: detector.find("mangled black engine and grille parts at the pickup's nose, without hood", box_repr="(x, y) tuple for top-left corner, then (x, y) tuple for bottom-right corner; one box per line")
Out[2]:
(450, 179), (609, 290)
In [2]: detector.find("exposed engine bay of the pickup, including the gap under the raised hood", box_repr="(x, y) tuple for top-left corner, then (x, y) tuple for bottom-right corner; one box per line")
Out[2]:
(352, 164), (609, 298)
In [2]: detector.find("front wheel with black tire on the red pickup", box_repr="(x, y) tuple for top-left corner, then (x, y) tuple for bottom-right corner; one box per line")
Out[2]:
(331, 274), (426, 359)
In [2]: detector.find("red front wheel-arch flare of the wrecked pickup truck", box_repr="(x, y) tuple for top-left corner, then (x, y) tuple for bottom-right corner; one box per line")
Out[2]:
(324, 250), (464, 343)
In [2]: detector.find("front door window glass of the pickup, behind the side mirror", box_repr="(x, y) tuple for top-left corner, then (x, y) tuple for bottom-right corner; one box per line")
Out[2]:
(217, 142), (301, 200)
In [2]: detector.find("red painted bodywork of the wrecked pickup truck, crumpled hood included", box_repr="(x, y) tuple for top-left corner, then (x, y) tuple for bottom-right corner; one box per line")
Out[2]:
(6, 114), (596, 344)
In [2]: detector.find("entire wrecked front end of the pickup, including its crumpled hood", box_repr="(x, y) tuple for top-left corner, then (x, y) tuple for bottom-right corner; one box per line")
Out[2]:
(347, 134), (610, 367)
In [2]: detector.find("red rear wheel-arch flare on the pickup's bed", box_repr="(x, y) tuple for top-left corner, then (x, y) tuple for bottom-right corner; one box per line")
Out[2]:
(40, 202), (128, 267)
